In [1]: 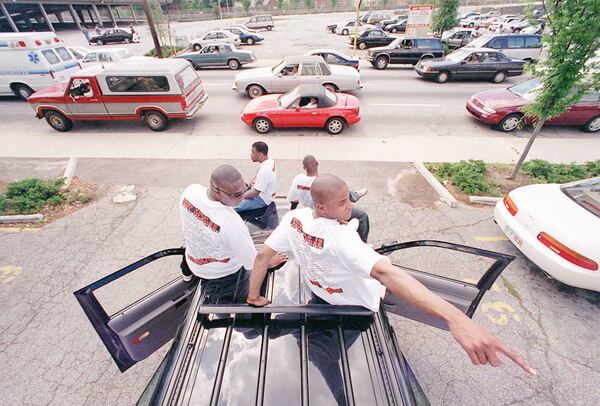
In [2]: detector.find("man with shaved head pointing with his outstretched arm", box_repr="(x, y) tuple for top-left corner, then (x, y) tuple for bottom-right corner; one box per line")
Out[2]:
(247, 174), (535, 374)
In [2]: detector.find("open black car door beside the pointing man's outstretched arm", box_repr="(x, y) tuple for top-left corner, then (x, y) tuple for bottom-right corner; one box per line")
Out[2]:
(376, 240), (515, 330)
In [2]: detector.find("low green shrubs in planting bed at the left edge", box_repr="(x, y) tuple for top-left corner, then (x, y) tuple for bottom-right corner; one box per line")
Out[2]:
(0, 178), (92, 215)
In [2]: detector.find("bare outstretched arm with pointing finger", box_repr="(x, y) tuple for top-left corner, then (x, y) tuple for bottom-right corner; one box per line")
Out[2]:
(371, 259), (536, 375)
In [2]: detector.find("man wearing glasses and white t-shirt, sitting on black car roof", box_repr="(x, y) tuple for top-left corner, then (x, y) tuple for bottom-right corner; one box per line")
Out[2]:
(179, 165), (287, 297)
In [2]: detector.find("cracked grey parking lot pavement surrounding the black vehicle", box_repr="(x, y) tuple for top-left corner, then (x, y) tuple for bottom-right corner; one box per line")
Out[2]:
(0, 157), (600, 405)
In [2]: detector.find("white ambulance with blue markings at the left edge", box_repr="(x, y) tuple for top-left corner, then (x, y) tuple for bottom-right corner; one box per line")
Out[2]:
(0, 32), (81, 100)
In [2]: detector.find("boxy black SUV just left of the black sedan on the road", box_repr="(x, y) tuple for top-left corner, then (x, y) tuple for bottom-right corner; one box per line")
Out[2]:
(367, 37), (444, 69)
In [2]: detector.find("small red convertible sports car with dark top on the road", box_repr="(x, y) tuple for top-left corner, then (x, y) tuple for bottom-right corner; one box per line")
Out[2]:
(241, 85), (360, 134)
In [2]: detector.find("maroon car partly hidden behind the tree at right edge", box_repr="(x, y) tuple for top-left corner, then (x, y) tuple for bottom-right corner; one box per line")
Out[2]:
(467, 78), (600, 133)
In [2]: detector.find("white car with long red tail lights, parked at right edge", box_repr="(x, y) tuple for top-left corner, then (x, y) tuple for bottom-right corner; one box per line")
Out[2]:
(494, 177), (600, 291)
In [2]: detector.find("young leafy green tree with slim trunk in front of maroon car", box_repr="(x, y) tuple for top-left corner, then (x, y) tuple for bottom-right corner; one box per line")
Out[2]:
(511, 0), (600, 179)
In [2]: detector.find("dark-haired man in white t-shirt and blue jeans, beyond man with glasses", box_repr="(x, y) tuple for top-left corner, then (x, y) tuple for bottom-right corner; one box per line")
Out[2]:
(235, 141), (277, 215)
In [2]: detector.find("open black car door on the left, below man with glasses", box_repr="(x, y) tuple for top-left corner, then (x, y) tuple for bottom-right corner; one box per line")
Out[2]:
(73, 248), (198, 372)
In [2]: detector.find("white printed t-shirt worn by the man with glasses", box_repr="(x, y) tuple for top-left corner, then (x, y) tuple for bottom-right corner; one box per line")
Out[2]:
(179, 184), (256, 279)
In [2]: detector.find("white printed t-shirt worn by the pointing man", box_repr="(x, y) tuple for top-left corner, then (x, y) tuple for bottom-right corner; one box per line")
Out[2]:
(265, 208), (388, 312)
